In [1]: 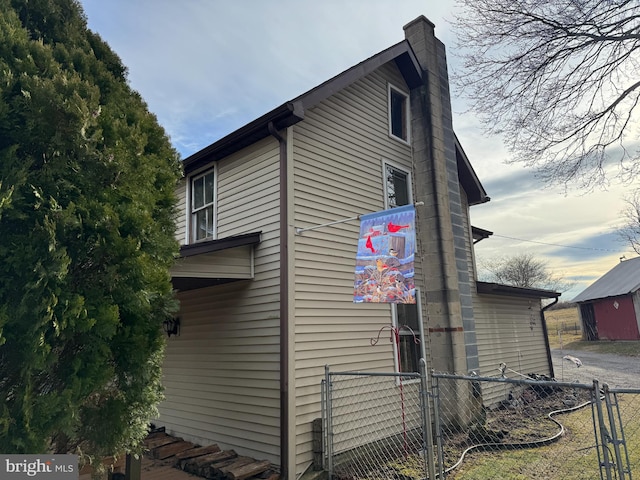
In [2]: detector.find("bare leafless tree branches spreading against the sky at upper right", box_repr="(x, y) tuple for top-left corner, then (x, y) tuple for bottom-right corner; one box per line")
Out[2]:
(454, 0), (640, 187)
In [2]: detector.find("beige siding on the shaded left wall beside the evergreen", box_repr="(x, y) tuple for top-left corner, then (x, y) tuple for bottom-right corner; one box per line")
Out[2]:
(157, 139), (280, 463)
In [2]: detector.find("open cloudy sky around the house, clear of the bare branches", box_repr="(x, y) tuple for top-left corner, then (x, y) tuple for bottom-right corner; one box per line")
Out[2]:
(81, 0), (635, 301)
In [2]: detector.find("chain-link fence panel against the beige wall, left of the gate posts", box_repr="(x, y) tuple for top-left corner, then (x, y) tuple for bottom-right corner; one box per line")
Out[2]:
(322, 364), (435, 480)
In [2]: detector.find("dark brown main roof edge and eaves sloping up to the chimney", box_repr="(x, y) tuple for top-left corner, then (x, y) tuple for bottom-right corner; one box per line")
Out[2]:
(182, 40), (422, 173)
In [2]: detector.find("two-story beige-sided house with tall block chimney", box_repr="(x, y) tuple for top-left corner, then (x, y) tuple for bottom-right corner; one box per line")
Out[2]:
(157, 17), (557, 478)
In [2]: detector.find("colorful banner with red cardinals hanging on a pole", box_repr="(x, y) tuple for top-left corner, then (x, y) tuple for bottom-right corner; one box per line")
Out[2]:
(353, 205), (416, 303)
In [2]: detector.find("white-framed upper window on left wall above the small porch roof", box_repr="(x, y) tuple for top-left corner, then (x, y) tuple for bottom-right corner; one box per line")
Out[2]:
(191, 170), (215, 242)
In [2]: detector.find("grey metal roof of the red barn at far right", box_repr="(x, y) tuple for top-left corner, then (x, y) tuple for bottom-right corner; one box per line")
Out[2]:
(572, 257), (640, 302)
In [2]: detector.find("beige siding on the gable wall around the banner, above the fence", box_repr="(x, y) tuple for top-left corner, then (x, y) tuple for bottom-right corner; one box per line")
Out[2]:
(293, 64), (419, 474)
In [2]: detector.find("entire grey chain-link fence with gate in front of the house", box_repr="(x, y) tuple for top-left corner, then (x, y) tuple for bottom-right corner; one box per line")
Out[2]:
(322, 367), (640, 480)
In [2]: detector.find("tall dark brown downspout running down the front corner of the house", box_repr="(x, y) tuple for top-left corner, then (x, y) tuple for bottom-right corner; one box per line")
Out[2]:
(268, 122), (289, 478)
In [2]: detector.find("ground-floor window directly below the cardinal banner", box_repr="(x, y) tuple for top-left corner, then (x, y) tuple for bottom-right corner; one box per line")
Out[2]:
(393, 303), (422, 373)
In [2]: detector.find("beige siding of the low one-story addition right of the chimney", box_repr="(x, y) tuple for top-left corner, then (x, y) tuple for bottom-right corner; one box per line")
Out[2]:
(474, 295), (550, 406)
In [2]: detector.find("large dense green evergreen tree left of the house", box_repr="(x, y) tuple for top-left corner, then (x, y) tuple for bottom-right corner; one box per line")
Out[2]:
(0, 0), (180, 462)
